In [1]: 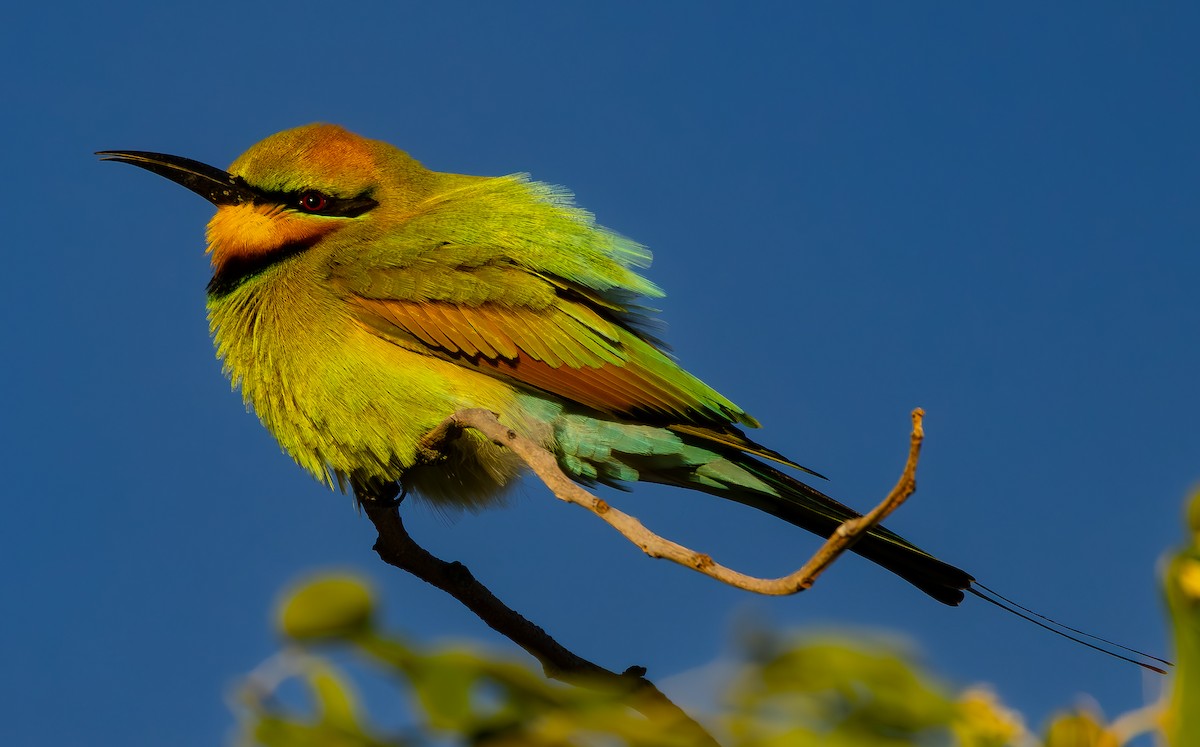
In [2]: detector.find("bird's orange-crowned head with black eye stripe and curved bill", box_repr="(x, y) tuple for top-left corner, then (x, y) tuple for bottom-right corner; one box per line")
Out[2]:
(97, 124), (432, 287)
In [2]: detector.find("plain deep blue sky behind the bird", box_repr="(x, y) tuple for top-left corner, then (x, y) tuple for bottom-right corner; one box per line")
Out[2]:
(0, 1), (1200, 746)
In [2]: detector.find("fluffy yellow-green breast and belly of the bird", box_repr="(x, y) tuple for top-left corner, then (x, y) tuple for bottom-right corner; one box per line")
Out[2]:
(209, 268), (526, 503)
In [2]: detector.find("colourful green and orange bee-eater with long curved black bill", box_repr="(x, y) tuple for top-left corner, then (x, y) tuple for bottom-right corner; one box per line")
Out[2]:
(97, 122), (1157, 668)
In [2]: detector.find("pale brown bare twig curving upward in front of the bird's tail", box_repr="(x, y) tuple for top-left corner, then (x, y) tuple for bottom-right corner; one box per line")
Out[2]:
(444, 407), (925, 596)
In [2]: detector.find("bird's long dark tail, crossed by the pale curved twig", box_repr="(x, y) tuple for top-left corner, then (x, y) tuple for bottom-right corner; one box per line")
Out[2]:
(642, 453), (974, 605)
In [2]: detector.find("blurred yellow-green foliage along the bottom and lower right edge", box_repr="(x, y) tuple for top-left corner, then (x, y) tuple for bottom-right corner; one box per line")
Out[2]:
(239, 492), (1200, 747)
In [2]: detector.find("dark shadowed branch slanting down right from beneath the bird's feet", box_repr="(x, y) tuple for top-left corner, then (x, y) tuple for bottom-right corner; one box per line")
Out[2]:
(359, 499), (720, 747)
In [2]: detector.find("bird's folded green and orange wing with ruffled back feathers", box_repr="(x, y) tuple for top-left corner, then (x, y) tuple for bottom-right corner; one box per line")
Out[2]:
(330, 172), (803, 468)
